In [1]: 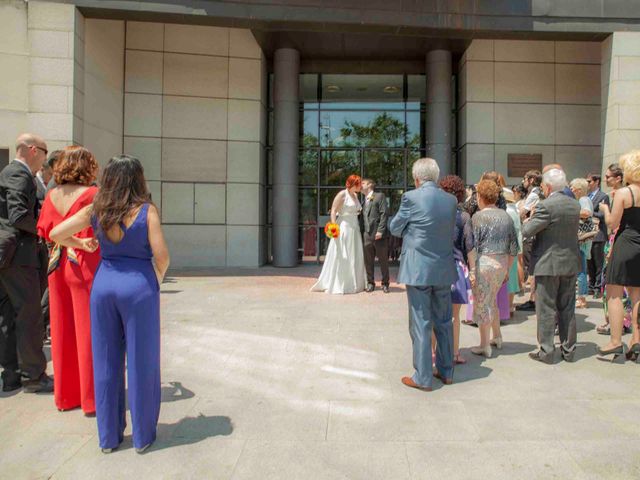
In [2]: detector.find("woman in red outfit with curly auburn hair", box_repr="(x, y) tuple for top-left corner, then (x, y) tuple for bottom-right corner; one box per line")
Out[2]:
(38, 146), (100, 416)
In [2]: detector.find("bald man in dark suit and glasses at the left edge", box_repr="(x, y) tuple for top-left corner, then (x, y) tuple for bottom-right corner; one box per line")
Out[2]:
(0, 133), (53, 393)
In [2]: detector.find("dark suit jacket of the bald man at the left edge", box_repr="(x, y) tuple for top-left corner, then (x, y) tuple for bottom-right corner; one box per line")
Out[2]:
(0, 161), (40, 267)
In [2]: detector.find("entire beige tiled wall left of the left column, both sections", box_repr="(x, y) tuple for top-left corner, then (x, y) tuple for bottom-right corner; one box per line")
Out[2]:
(0, 0), (266, 267)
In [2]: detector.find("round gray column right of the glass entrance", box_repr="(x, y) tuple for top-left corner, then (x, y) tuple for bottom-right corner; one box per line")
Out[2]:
(425, 50), (453, 175)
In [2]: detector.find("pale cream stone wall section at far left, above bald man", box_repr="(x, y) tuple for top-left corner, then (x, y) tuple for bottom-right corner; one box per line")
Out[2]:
(0, 0), (84, 157)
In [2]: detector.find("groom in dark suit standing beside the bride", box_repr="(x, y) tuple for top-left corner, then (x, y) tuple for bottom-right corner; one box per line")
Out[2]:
(362, 178), (389, 293)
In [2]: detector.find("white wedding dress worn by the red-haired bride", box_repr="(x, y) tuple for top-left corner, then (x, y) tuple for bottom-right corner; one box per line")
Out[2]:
(311, 191), (366, 294)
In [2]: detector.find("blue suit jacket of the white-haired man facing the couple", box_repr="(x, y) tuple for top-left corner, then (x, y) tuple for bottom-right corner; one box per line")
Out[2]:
(389, 182), (457, 286)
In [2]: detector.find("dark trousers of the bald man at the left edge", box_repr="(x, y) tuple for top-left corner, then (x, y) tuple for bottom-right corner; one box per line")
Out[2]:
(0, 266), (47, 380)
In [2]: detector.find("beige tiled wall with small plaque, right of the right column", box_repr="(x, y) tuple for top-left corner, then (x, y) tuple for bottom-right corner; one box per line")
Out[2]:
(458, 40), (601, 183)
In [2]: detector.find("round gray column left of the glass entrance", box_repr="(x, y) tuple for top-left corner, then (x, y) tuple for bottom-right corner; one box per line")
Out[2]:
(272, 48), (300, 267)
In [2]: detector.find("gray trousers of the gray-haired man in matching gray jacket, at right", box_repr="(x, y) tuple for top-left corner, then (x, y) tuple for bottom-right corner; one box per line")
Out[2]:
(536, 275), (577, 357)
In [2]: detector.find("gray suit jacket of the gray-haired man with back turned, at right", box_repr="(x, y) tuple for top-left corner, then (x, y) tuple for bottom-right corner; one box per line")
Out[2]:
(522, 192), (582, 276)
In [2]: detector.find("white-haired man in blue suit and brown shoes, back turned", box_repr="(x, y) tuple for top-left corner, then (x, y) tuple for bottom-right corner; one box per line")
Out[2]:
(390, 158), (457, 391)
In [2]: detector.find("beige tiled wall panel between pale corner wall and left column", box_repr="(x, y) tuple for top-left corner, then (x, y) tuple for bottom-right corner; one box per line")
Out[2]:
(123, 22), (266, 267)
